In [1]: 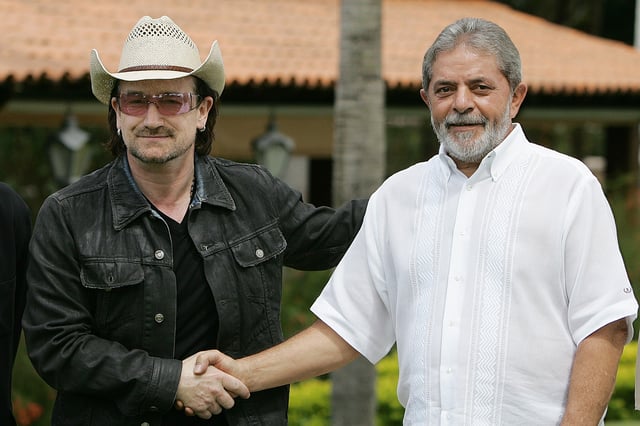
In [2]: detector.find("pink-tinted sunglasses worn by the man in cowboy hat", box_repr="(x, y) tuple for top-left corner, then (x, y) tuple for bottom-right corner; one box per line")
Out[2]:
(117, 93), (200, 117)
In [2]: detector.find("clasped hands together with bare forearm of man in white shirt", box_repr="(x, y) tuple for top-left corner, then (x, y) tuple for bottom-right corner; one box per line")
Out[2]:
(175, 320), (360, 419)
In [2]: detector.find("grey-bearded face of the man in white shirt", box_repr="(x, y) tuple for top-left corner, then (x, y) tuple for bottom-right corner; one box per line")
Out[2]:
(420, 44), (527, 164)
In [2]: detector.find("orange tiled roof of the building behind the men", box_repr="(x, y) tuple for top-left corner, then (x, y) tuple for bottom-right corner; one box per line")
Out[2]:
(0, 0), (640, 94)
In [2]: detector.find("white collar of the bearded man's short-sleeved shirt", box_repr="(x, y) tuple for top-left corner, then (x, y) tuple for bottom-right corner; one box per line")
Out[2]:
(438, 123), (526, 181)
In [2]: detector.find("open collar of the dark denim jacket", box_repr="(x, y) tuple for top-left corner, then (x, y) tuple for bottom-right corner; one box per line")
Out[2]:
(107, 155), (236, 230)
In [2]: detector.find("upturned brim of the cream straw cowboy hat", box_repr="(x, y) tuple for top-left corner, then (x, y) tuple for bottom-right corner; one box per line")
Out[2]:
(89, 40), (224, 105)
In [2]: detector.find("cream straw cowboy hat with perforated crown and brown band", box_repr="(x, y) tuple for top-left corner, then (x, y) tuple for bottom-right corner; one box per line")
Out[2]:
(90, 16), (224, 105)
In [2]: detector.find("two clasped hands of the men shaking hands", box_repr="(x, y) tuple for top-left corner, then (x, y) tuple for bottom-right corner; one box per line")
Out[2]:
(175, 350), (249, 419)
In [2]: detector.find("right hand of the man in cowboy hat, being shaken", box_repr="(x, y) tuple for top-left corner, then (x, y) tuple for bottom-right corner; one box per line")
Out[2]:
(176, 355), (249, 419)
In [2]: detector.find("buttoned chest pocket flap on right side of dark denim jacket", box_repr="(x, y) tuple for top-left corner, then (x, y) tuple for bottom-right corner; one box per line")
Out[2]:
(229, 225), (287, 268)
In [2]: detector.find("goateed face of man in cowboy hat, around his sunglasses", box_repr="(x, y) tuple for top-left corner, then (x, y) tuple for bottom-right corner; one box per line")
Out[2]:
(111, 77), (213, 164)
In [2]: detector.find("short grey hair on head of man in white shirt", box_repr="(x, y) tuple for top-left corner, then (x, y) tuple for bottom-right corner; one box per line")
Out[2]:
(422, 18), (522, 91)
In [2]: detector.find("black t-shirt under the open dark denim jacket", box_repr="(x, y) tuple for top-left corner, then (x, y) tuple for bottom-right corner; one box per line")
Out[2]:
(160, 213), (227, 426)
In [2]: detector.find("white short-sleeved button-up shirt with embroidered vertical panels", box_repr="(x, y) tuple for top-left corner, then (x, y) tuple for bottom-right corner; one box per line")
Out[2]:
(312, 125), (638, 425)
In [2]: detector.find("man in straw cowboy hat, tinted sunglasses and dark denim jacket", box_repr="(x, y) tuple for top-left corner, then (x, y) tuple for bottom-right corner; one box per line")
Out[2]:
(24, 17), (365, 426)
